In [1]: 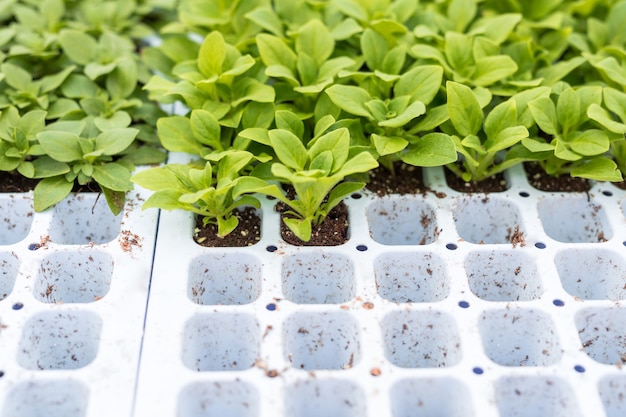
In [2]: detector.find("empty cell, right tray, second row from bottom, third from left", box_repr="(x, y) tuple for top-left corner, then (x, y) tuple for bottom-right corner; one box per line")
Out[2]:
(381, 310), (461, 368)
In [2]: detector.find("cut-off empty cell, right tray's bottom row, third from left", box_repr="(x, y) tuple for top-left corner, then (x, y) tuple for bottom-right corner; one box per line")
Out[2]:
(390, 378), (476, 417)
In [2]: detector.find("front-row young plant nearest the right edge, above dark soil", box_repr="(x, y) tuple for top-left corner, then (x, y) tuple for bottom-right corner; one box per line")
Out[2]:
(523, 83), (622, 181)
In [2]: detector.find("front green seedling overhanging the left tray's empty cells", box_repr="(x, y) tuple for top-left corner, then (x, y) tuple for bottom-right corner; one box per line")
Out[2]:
(34, 121), (139, 214)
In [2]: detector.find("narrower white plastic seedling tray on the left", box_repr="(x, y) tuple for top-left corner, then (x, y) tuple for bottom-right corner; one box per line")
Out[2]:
(0, 186), (158, 417)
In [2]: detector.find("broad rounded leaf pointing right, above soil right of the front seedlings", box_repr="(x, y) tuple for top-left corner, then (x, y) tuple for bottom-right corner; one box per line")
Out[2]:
(401, 133), (457, 167)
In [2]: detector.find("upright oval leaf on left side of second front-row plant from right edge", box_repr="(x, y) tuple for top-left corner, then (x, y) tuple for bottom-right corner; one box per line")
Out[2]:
(446, 81), (483, 136)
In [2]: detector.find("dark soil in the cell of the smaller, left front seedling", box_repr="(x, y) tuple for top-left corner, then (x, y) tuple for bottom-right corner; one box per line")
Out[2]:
(193, 207), (261, 248)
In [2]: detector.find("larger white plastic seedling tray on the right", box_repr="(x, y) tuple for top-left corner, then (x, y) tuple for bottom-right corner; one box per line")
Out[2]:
(135, 162), (626, 417)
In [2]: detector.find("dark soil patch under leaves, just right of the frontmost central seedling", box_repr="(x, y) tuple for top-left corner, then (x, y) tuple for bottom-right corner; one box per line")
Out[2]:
(365, 161), (426, 196)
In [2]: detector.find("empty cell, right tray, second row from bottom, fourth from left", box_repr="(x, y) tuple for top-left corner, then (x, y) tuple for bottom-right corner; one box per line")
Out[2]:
(479, 308), (562, 366)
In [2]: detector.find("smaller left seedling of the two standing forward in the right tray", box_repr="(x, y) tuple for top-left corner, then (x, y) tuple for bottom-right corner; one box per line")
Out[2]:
(131, 151), (278, 237)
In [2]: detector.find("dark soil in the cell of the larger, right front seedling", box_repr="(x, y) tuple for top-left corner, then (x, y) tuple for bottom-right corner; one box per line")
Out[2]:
(276, 202), (349, 246)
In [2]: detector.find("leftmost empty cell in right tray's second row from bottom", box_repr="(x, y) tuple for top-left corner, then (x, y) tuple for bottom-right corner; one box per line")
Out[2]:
(182, 312), (260, 372)
